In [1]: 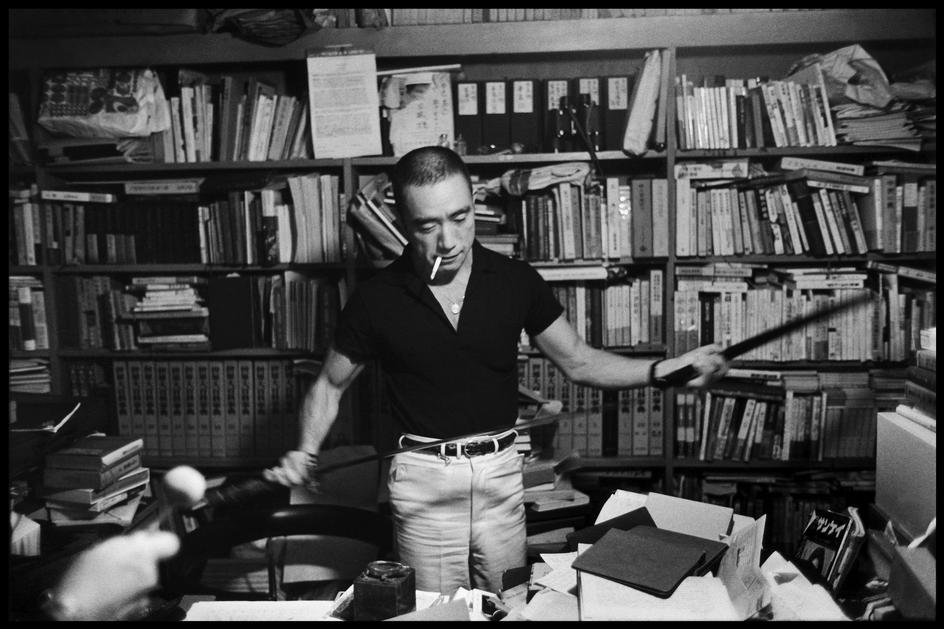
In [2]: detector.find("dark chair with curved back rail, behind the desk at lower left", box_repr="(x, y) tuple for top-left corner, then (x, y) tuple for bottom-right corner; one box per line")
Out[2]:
(162, 504), (394, 600)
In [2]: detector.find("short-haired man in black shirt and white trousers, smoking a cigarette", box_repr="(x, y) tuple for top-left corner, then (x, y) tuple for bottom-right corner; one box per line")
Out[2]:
(266, 147), (727, 594)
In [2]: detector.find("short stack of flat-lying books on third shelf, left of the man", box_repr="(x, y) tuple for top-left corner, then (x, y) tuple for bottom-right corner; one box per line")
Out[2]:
(128, 276), (210, 349)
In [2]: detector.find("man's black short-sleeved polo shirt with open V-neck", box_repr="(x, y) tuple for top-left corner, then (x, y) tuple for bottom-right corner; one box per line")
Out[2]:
(334, 241), (564, 439)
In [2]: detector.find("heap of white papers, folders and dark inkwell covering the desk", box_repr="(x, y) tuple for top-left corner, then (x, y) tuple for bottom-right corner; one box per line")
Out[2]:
(181, 490), (872, 621)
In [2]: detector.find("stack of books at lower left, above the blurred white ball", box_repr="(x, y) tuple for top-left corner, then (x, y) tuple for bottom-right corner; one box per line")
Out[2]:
(42, 435), (150, 525)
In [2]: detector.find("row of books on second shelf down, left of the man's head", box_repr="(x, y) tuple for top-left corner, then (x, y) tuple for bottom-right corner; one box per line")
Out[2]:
(28, 173), (346, 264)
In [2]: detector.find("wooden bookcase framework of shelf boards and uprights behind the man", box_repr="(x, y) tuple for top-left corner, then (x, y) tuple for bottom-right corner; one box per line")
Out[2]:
(10, 9), (936, 544)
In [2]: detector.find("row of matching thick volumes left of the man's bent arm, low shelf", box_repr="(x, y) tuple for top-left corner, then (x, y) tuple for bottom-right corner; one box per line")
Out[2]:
(112, 359), (301, 459)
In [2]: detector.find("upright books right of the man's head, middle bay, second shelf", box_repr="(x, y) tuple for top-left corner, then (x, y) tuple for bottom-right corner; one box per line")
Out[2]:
(518, 176), (669, 262)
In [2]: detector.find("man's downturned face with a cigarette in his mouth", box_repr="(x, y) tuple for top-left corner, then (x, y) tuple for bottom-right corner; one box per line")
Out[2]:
(403, 175), (475, 282)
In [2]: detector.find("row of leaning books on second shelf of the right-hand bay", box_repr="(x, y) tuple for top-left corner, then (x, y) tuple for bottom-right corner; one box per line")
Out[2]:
(675, 157), (937, 256)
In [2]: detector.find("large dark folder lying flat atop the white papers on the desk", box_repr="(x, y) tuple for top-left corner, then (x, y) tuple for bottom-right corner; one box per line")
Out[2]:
(571, 526), (727, 598)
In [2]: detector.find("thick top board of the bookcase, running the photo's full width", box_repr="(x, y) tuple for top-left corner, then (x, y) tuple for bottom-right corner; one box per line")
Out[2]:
(9, 9), (937, 70)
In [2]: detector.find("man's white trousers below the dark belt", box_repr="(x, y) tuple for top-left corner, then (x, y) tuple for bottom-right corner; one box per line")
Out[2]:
(387, 444), (527, 594)
